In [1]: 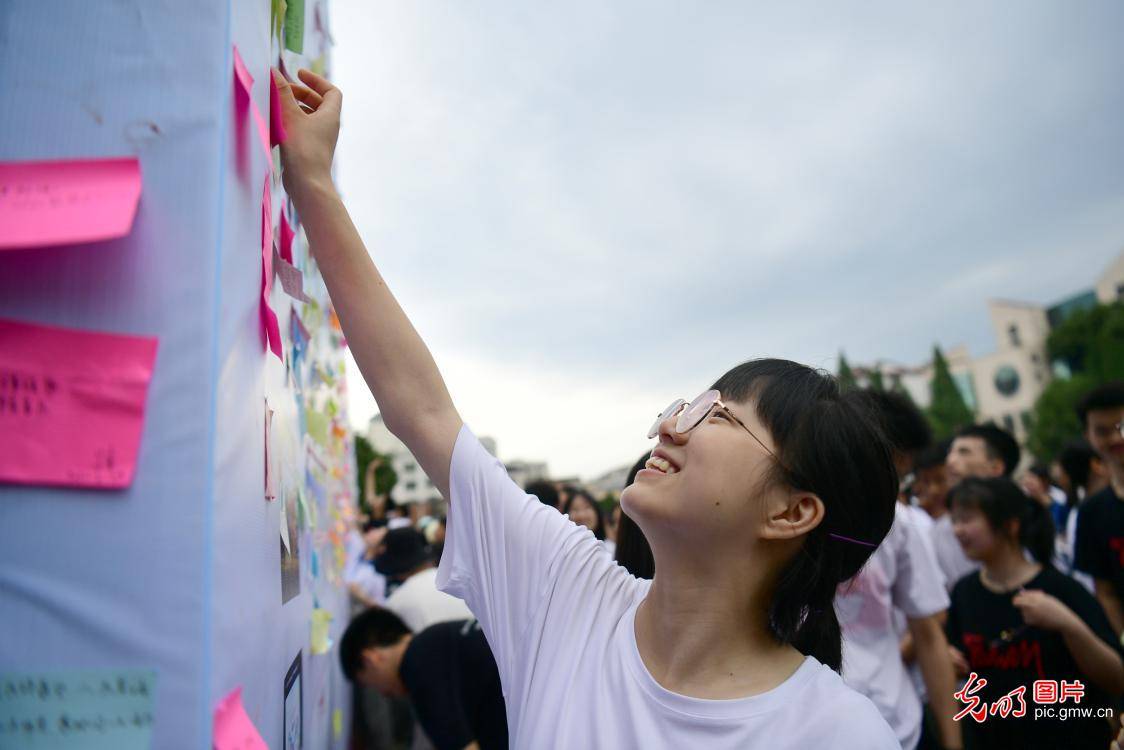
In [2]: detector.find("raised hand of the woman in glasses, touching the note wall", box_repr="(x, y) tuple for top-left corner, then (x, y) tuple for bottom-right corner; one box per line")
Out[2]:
(273, 69), (343, 204)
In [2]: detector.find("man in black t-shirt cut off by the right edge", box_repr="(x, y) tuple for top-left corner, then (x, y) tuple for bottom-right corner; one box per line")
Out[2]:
(1073, 381), (1124, 638)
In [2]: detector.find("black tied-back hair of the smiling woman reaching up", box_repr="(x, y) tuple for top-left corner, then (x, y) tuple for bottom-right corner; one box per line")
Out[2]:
(713, 359), (898, 671)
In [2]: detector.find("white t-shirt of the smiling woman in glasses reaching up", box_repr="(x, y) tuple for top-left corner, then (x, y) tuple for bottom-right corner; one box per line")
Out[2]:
(437, 427), (898, 750)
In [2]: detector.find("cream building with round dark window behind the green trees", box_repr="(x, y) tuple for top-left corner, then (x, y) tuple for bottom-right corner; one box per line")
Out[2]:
(853, 252), (1124, 443)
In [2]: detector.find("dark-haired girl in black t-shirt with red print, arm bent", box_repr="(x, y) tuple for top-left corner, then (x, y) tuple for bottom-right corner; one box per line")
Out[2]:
(948, 478), (1124, 750)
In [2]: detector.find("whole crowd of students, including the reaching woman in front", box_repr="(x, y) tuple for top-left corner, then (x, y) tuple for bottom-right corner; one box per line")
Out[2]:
(277, 71), (1124, 749)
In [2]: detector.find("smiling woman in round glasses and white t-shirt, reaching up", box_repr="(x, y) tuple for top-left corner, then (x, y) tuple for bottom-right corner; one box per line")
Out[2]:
(274, 71), (900, 750)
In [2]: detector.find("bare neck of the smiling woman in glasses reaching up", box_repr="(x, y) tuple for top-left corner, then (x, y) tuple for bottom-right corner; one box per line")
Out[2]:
(635, 548), (804, 699)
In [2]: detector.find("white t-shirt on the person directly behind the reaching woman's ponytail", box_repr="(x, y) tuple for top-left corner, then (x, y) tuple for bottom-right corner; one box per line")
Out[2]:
(835, 503), (949, 748)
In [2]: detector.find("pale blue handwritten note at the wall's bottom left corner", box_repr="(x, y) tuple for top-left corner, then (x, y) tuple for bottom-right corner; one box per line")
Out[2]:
(0, 669), (156, 750)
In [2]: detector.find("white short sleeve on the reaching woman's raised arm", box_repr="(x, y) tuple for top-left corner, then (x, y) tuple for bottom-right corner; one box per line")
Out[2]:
(437, 426), (596, 685)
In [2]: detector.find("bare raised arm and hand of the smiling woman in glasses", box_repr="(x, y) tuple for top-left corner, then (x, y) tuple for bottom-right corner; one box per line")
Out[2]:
(273, 70), (461, 492)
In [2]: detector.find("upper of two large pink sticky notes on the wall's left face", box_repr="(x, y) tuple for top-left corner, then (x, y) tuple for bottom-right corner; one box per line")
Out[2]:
(0, 157), (141, 250)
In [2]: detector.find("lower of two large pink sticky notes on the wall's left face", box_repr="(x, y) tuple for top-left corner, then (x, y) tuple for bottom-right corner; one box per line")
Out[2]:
(0, 319), (156, 489)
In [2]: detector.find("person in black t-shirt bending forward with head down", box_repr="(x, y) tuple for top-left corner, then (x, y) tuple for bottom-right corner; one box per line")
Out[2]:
(339, 607), (507, 750)
